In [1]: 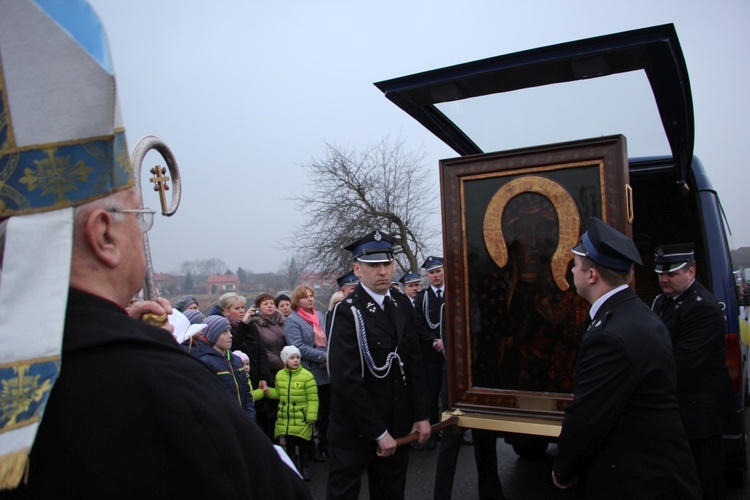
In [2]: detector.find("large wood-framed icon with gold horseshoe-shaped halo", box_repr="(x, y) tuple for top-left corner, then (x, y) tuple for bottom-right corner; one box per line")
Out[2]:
(440, 136), (632, 418)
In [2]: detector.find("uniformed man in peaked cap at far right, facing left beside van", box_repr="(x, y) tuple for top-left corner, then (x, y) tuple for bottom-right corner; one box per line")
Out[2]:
(652, 243), (731, 499)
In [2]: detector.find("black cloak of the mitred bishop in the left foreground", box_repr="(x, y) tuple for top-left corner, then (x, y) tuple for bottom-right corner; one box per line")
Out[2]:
(5, 290), (312, 499)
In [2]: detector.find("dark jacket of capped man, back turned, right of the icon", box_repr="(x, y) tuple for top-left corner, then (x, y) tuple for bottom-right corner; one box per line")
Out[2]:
(554, 288), (701, 500)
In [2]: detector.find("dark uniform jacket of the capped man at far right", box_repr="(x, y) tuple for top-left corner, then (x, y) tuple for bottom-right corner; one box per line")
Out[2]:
(652, 281), (731, 439)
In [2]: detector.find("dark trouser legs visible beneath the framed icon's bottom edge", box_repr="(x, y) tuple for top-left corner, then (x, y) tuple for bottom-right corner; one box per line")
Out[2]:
(433, 427), (505, 500)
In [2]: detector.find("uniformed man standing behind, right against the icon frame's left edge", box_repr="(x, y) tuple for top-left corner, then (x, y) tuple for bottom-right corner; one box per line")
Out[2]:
(415, 256), (445, 450)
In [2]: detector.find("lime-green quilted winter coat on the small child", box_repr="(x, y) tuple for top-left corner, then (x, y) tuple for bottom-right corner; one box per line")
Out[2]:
(268, 366), (318, 441)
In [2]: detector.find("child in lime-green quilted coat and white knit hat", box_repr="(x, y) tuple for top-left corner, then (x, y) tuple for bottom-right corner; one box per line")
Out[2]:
(268, 345), (318, 481)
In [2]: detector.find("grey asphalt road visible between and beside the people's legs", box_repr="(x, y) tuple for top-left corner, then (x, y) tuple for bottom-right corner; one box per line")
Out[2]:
(308, 411), (750, 500)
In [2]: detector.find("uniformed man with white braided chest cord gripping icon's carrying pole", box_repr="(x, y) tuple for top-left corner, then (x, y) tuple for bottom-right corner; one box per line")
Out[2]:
(326, 231), (430, 500)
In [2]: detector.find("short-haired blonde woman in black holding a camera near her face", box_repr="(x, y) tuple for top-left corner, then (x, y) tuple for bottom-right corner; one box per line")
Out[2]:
(209, 292), (271, 393)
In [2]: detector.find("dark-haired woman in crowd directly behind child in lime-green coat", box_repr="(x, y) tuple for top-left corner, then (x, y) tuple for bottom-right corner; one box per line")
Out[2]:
(250, 293), (287, 439)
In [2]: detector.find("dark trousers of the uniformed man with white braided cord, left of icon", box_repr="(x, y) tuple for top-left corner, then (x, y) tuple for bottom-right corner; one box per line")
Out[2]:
(326, 444), (409, 500)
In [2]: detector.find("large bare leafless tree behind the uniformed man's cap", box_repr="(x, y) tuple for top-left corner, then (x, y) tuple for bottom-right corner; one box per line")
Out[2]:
(288, 138), (439, 273)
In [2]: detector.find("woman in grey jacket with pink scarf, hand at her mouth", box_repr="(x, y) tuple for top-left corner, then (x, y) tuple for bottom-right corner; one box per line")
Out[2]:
(284, 285), (331, 461)
